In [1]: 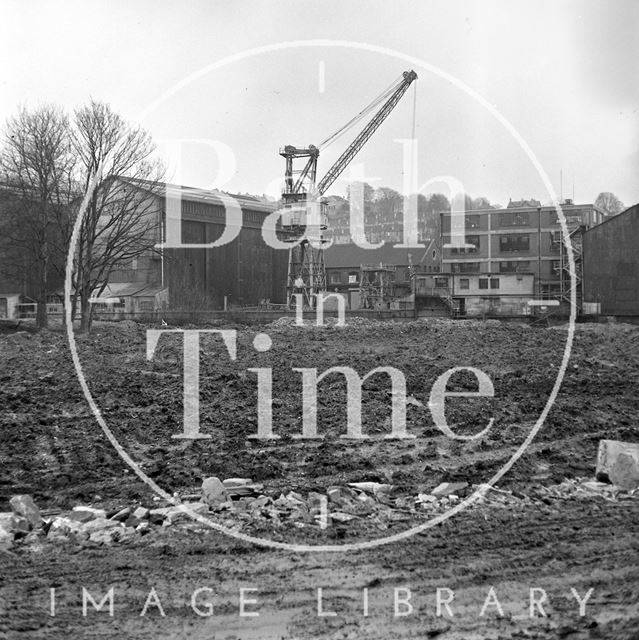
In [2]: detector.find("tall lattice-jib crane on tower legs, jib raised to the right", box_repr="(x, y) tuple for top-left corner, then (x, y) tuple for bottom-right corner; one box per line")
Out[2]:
(279, 70), (417, 309)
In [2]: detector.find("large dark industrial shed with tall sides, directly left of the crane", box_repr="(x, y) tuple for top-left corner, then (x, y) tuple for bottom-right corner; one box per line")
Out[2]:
(93, 183), (288, 313)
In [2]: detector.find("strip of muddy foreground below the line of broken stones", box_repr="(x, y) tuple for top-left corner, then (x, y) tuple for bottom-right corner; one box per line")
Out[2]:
(0, 501), (639, 640)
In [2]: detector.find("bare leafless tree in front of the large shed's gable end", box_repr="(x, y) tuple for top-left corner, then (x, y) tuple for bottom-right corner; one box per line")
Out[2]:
(73, 100), (164, 331)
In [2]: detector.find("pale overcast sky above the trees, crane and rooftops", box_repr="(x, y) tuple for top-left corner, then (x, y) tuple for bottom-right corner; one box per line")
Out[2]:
(0, 0), (639, 206)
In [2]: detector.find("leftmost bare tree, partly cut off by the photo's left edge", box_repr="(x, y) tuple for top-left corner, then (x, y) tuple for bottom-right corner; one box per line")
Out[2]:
(0, 105), (74, 328)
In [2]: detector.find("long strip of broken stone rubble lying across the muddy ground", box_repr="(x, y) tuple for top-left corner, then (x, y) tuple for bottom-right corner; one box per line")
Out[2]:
(0, 470), (639, 550)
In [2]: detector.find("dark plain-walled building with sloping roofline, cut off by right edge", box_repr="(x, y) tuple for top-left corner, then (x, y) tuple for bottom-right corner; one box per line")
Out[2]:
(583, 204), (639, 317)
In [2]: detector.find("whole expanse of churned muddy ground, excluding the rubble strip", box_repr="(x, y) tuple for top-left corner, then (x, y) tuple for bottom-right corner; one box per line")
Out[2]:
(0, 319), (639, 639)
